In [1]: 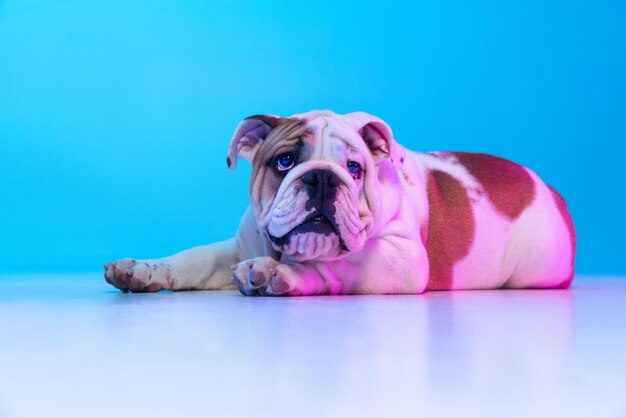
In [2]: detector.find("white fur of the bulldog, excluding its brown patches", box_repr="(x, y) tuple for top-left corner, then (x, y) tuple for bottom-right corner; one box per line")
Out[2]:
(106, 111), (572, 295)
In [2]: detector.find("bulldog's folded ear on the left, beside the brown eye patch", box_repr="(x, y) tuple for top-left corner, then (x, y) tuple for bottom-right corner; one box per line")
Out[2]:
(226, 115), (280, 170)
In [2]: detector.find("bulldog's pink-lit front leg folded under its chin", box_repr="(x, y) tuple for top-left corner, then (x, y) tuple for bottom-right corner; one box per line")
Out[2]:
(232, 236), (429, 296)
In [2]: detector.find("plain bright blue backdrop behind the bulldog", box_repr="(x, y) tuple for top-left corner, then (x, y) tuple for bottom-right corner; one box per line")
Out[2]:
(0, 0), (626, 274)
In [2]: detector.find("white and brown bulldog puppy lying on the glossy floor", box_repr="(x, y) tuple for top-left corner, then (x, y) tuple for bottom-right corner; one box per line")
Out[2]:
(105, 111), (576, 296)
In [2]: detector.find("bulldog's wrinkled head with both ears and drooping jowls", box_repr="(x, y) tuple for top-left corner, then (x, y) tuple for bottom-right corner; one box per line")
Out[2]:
(227, 111), (404, 261)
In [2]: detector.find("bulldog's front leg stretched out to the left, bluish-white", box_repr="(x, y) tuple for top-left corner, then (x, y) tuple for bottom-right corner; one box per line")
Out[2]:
(104, 238), (239, 292)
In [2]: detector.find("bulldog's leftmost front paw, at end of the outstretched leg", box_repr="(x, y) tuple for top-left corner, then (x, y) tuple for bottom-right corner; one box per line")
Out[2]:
(104, 258), (174, 292)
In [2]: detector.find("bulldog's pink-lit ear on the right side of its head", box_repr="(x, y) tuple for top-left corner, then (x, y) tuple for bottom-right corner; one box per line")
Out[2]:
(346, 112), (406, 168)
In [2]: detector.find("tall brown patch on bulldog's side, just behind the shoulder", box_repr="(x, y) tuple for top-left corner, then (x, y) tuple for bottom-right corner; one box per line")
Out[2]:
(426, 170), (475, 290)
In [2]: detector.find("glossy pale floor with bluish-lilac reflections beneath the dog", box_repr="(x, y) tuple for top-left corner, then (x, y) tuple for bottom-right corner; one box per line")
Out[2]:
(0, 275), (626, 418)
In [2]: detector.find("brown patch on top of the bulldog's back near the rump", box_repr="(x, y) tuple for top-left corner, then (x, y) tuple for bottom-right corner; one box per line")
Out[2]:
(452, 152), (536, 221)
